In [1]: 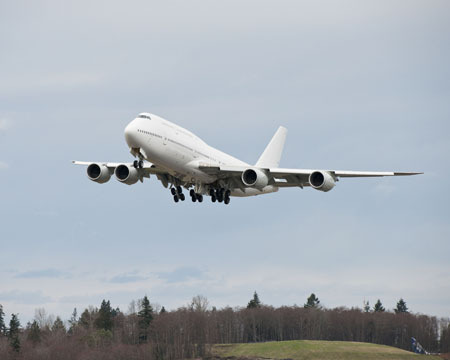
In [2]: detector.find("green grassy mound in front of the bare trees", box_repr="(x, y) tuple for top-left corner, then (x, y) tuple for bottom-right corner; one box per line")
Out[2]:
(213, 340), (441, 360)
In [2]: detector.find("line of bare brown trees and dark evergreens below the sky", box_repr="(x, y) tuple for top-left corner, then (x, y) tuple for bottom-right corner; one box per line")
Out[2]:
(0, 292), (450, 360)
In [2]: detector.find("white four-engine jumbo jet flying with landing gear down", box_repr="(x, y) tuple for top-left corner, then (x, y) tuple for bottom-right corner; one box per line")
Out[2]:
(73, 113), (422, 204)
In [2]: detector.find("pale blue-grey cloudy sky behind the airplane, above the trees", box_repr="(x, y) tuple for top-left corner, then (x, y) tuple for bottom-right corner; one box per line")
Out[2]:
(0, 0), (450, 324)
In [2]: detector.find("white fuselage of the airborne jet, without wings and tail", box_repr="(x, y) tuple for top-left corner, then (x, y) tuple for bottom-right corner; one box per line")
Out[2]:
(125, 113), (278, 196)
